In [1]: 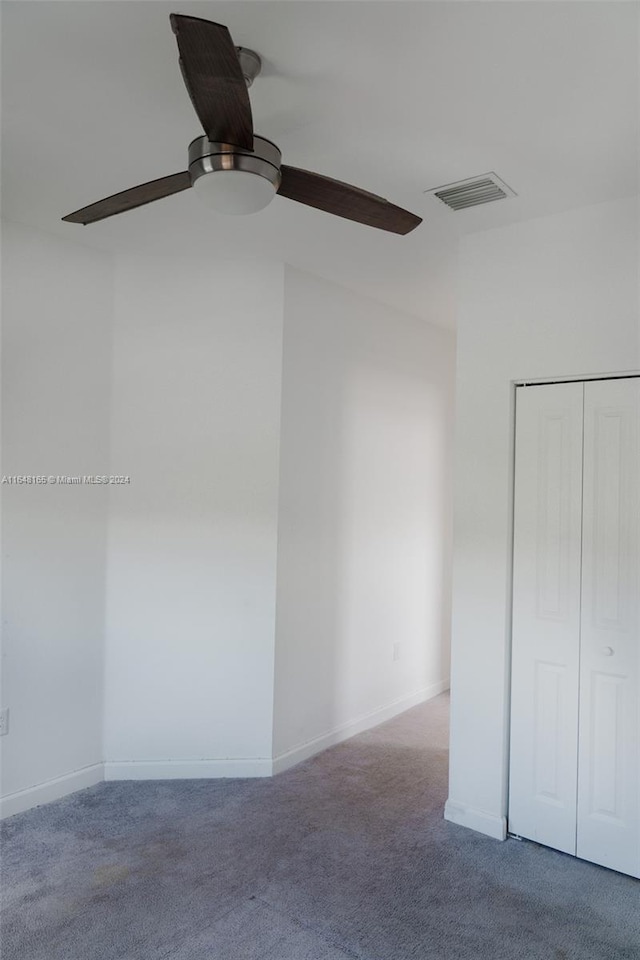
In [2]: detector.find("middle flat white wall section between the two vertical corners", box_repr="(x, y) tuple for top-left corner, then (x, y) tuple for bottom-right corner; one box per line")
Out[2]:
(105, 257), (283, 764)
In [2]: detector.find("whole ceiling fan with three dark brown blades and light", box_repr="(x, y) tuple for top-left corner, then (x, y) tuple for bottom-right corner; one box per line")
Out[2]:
(62, 13), (422, 234)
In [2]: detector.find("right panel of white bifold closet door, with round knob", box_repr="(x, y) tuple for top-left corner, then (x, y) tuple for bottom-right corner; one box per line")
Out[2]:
(577, 378), (640, 877)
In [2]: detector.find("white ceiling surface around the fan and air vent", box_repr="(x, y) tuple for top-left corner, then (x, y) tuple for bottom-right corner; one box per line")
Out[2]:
(2, 0), (640, 325)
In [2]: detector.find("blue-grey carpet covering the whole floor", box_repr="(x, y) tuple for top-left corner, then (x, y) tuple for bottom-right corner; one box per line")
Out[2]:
(1, 695), (640, 960)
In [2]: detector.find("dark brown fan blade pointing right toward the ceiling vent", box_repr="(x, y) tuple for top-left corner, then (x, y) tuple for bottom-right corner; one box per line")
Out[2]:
(278, 164), (422, 234)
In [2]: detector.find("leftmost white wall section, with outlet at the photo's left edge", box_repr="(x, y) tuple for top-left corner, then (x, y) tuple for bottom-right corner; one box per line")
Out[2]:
(0, 223), (113, 808)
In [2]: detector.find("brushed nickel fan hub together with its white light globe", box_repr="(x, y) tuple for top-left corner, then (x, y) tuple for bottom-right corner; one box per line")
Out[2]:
(189, 136), (281, 215)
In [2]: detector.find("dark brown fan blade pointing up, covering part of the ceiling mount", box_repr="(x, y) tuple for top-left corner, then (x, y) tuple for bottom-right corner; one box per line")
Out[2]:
(170, 13), (253, 150)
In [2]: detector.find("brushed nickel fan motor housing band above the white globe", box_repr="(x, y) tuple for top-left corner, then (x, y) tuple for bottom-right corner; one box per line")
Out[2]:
(189, 134), (282, 192)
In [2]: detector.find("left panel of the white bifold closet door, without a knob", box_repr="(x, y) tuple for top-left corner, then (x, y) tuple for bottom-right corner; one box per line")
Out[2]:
(509, 383), (583, 854)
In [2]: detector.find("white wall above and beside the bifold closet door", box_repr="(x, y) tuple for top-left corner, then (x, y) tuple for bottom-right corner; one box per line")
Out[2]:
(449, 200), (640, 835)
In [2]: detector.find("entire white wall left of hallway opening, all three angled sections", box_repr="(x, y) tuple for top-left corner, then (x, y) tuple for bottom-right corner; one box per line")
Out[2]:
(0, 234), (454, 813)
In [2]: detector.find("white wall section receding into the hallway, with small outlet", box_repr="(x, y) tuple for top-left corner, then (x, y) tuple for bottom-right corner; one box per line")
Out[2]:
(274, 268), (455, 756)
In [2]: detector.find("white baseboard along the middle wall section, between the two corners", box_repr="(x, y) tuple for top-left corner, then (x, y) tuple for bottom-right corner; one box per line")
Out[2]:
(104, 757), (273, 780)
